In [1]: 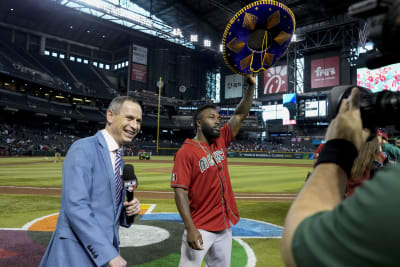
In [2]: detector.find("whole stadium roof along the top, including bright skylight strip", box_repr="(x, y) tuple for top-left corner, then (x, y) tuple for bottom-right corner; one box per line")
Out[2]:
(0, 0), (359, 52)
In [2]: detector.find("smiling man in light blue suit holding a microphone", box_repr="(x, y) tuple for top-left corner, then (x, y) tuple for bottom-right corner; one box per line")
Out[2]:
(40, 96), (142, 267)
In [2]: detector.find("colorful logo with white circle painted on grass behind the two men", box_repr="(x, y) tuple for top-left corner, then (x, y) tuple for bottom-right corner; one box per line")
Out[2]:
(0, 204), (282, 267)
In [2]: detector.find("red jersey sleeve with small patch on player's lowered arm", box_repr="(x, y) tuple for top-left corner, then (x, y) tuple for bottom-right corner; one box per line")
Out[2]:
(171, 148), (193, 190)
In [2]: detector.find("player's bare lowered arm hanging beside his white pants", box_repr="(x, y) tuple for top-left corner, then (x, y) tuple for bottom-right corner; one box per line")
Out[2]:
(174, 188), (204, 250)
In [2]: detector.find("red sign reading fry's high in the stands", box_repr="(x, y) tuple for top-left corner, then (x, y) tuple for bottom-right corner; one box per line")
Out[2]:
(311, 56), (340, 88)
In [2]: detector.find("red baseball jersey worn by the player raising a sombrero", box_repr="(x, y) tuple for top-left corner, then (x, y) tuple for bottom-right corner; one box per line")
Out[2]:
(171, 123), (240, 231)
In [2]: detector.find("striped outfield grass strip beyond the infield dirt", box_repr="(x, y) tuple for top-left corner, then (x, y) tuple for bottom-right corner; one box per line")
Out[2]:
(0, 156), (311, 193)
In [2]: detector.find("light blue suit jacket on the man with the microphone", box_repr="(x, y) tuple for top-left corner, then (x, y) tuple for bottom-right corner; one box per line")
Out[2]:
(40, 132), (130, 267)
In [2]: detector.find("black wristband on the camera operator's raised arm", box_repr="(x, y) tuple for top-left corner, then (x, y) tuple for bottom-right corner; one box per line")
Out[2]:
(314, 139), (358, 178)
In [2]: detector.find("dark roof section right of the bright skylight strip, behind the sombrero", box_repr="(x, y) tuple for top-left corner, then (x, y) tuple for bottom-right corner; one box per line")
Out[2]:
(131, 0), (360, 48)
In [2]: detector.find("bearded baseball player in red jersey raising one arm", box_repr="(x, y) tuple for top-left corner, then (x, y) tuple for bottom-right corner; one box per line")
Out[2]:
(171, 75), (255, 267)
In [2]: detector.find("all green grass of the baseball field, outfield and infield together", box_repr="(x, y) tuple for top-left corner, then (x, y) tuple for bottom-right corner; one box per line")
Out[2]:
(0, 157), (312, 267)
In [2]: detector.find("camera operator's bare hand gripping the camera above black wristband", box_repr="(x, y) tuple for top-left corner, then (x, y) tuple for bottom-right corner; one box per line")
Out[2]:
(325, 87), (369, 150)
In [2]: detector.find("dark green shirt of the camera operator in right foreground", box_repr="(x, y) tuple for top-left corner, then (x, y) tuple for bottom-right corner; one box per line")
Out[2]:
(292, 164), (400, 267)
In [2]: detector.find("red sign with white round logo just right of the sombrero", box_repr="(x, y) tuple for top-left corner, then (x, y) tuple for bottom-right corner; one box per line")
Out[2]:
(264, 65), (287, 95)
